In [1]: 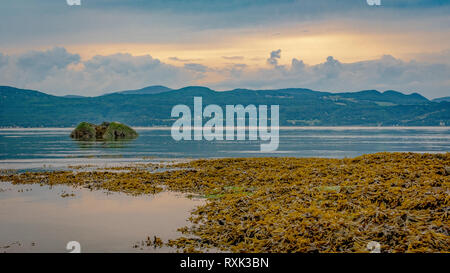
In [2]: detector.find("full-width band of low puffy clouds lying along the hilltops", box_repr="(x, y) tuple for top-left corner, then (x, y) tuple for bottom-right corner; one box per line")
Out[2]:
(0, 48), (450, 98)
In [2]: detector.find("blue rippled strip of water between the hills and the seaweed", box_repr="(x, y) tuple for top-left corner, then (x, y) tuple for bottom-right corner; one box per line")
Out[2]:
(0, 127), (450, 169)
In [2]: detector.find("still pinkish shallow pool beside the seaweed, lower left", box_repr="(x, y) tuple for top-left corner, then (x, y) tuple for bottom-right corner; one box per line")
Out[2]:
(0, 182), (203, 253)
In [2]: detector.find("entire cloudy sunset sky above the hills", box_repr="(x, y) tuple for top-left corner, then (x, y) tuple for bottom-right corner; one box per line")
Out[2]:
(0, 0), (450, 98)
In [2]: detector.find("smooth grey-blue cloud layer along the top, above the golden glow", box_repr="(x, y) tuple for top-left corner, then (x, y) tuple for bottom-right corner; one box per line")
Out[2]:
(0, 0), (450, 47)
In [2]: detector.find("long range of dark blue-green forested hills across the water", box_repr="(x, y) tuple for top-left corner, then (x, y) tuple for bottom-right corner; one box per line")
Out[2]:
(0, 86), (450, 127)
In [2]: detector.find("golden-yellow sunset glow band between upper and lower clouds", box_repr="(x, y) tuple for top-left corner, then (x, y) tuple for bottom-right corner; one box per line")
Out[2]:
(59, 27), (450, 67)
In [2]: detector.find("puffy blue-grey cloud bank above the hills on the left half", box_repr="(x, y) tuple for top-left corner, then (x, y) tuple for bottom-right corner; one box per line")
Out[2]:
(0, 48), (198, 96)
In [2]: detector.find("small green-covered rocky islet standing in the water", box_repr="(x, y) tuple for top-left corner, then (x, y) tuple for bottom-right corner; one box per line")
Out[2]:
(70, 122), (138, 140)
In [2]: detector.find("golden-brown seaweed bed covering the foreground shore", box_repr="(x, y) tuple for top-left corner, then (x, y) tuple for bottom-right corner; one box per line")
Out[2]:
(0, 153), (450, 253)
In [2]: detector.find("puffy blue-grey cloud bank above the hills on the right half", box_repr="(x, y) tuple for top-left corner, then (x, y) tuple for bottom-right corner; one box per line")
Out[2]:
(211, 51), (450, 98)
